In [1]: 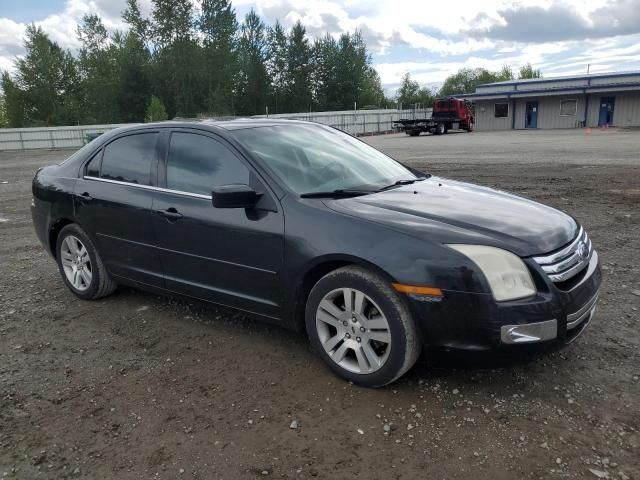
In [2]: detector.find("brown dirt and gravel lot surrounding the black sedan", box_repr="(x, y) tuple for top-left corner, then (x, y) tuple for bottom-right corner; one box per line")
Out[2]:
(0, 130), (640, 480)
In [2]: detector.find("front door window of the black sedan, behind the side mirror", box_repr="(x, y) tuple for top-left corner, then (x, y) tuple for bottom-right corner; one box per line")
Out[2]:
(167, 132), (249, 195)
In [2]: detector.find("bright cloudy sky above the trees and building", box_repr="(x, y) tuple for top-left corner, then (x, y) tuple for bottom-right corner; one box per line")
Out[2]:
(0, 0), (640, 93)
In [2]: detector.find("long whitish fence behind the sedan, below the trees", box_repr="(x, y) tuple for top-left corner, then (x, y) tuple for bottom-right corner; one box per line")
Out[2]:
(0, 109), (431, 150)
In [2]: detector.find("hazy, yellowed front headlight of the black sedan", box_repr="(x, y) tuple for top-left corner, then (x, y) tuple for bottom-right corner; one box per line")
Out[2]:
(448, 245), (536, 302)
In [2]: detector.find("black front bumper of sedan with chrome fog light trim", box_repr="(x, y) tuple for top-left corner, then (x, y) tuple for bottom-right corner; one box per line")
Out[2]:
(411, 251), (602, 350)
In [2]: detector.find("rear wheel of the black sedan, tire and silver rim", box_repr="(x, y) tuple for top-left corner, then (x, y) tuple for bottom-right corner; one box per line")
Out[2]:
(56, 224), (118, 300)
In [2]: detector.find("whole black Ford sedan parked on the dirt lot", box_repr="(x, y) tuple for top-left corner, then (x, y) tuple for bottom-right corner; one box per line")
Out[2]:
(32, 120), (601, 386)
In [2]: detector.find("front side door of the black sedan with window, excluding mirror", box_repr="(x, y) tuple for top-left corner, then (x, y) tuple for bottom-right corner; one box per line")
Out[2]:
(152, 129), (284, 318)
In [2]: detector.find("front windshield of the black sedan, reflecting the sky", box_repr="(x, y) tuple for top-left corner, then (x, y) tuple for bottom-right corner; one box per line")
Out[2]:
(233, 124), (417, 194)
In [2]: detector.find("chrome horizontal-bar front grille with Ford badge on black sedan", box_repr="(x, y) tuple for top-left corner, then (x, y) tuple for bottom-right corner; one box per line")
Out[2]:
(533, 227), (593, 283)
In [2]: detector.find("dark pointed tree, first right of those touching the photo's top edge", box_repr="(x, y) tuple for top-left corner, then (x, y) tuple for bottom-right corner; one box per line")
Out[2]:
(235, 9), (269, 115)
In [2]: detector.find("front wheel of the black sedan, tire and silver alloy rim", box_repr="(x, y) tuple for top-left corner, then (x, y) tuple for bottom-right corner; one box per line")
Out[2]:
(305, 266), (422, 387)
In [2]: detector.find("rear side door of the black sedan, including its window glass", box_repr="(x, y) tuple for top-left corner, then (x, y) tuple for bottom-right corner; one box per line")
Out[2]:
(74, 131), (164, 287)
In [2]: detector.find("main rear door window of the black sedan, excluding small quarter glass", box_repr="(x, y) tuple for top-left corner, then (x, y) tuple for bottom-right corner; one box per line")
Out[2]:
(100, 132), (158, 185)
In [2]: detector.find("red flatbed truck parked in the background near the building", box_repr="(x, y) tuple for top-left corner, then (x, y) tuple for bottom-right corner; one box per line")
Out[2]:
(393, 97), (473, 137)
